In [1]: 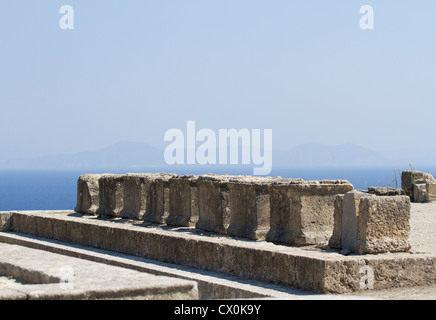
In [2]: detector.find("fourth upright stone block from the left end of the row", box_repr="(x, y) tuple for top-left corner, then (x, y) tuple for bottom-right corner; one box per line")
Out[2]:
(143, 173), (176, 224)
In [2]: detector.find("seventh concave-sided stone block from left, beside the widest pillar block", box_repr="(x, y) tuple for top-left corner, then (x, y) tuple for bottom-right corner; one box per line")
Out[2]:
(227, 176), (271, 240)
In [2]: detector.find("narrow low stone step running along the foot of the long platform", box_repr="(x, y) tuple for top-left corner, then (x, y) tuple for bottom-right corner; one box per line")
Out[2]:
(0, 232), (316, 300)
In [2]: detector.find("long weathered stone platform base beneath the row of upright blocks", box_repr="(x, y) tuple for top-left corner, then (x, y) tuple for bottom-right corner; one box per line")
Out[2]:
(1, 210), (436, 293)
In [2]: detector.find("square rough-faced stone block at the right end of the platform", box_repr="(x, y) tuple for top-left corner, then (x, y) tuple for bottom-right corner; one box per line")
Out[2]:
(355, 196), (410, 254)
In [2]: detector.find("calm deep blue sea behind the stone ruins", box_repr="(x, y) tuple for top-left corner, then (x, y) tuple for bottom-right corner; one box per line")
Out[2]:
(0, 166), (436, 211)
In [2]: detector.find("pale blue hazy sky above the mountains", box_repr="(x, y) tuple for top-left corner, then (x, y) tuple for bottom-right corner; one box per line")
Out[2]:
(0, 0), (436, 158)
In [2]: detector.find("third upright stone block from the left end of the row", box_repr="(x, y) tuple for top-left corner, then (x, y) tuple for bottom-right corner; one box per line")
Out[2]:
(120, 173), (153, 220)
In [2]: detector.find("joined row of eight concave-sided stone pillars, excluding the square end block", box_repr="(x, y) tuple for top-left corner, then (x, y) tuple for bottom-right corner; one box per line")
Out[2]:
(75, 173), (353, 245)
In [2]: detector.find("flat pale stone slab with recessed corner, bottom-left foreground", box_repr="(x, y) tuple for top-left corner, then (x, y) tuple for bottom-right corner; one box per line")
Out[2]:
(0, 245), (198, 299)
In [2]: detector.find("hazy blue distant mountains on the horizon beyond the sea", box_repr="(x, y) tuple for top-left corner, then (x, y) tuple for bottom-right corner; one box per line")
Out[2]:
(0, 141), (436, 169)
